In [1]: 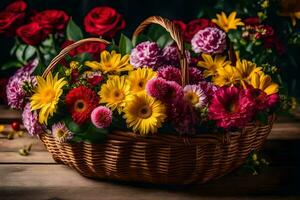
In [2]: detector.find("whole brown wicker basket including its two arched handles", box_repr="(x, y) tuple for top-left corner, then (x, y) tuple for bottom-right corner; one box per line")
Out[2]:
(39, 17), (273, 184)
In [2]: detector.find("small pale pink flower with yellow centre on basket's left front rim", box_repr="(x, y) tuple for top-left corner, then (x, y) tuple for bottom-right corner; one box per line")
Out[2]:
(52, 122), (74, 143)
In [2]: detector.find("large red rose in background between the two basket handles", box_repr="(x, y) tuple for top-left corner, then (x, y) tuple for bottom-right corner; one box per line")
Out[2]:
(84, 7), (126, 38)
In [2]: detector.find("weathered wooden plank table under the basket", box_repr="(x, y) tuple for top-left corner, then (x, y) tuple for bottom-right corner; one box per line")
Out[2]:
(0, 105), (300, 200)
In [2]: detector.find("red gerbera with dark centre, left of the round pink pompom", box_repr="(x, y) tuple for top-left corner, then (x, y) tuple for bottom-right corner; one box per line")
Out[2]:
(66, 86), (99, 124)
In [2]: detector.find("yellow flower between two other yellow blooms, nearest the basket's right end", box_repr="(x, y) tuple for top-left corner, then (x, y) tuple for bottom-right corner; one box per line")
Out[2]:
(236, 59), (262, 81)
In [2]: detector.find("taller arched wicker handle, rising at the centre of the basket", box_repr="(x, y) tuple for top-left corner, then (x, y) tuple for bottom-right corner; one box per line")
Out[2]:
(132, 16), (189, 86)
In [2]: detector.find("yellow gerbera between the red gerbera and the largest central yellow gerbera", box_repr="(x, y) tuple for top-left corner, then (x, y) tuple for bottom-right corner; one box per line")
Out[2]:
(98, 76), (132, 113)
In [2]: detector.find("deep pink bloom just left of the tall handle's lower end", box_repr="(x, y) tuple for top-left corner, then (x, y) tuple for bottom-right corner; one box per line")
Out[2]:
(157, 65), (181, 84)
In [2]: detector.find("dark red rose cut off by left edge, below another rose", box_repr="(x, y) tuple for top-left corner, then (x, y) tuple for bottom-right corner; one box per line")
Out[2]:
(0, 11), (25, 36)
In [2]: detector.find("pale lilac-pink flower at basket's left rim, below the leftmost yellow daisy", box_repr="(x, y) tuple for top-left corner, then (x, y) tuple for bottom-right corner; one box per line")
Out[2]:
(22, 103), (42, 135)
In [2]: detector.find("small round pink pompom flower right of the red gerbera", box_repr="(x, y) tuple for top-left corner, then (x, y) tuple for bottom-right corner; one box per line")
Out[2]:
(91, 106), (112, 128)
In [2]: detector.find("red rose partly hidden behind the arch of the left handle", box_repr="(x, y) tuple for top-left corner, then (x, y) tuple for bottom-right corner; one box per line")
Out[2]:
(62, 40), (106, 59)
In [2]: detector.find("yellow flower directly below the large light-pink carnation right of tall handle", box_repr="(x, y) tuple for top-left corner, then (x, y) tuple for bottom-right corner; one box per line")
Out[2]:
(197, 53), (230, 77)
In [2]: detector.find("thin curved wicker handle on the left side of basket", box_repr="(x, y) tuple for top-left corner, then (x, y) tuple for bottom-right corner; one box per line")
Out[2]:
(42, 38), (110, 78)
